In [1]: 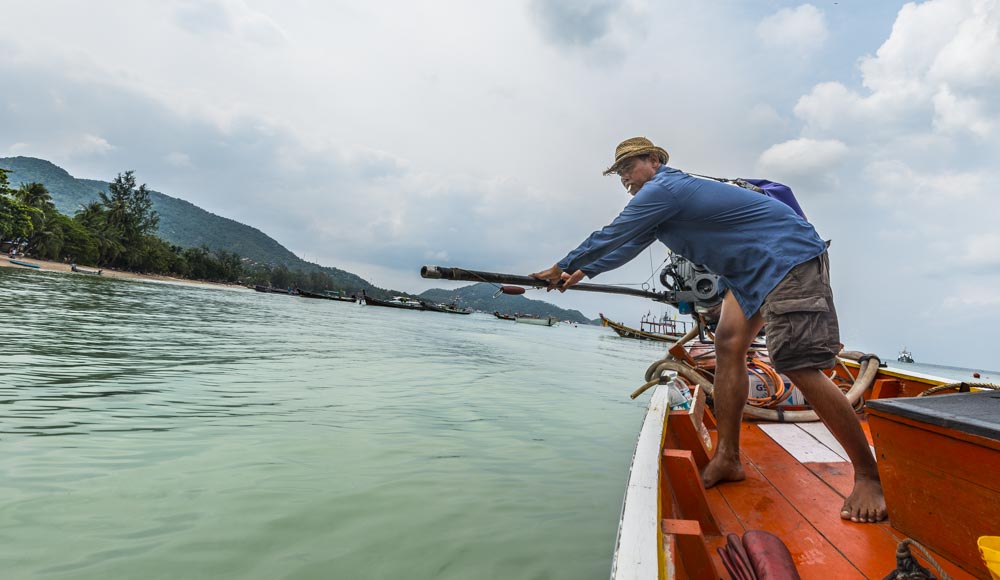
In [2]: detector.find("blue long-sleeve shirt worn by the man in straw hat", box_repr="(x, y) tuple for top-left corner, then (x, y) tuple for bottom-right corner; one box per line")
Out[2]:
(557, 165), (826, 318)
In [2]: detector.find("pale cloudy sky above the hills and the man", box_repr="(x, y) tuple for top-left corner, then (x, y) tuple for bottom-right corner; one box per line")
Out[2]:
(0, 0), (1000, 368)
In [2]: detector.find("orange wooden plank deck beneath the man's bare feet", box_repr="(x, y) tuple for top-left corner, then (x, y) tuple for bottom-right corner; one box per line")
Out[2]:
(706, 422), (974, 579)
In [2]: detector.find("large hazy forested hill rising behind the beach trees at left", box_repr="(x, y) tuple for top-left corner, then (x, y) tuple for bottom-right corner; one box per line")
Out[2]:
(0, 157), (371, 288)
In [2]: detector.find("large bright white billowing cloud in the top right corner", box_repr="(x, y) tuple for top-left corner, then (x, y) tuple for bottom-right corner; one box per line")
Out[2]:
(795, 0), (1000, 137)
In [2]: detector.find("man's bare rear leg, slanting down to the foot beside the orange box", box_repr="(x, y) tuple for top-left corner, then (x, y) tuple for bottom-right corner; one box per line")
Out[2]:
(785, 369), (886, 522)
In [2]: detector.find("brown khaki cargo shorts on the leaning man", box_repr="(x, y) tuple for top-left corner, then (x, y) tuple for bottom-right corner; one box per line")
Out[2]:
(760, 252), (840, 372)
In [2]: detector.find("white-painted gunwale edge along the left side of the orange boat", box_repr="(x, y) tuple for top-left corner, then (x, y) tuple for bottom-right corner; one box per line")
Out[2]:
(611, 385), (669, 580)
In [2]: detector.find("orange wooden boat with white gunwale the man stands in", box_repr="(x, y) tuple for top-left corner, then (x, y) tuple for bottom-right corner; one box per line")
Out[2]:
(611, 328), (1000, 579)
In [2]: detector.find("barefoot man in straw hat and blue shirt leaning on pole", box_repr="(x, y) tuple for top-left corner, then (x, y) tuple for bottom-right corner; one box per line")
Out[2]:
(532, 137), (886, 522)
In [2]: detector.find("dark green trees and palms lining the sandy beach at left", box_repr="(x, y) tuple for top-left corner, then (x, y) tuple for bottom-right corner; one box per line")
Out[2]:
(0, 168), (360, 291)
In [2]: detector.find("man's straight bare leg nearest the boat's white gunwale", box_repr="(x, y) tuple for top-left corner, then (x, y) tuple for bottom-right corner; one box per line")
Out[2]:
(701, 291), (764, 488)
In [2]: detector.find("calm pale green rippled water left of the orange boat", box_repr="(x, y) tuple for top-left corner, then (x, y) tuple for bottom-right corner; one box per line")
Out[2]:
(0, 268), (662, 579)
